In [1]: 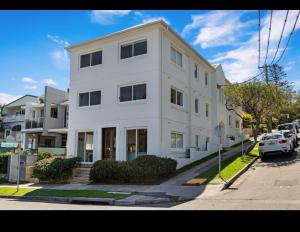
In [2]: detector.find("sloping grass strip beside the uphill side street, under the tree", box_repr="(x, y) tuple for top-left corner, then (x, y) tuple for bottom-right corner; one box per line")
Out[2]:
(195, 144), (258, 184)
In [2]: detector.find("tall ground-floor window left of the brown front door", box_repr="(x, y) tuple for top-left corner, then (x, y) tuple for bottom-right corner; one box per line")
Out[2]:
(77, 132), (94, 162)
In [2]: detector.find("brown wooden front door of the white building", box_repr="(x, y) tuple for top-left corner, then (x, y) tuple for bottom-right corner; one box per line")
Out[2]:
(102, 127), (116, 160)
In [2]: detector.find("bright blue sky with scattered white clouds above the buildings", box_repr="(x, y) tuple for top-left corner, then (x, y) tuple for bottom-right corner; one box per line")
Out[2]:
(0, 10), (300, 104)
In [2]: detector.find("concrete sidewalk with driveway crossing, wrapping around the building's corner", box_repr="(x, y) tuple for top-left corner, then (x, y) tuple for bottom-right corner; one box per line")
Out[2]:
(0, 142), (252, 205)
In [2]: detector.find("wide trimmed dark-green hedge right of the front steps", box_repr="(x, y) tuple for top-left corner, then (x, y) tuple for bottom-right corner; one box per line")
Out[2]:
(90, 155), (177, 183)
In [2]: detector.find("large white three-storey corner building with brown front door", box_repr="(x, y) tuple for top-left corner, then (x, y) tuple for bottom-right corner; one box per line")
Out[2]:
(67, 20), (241, 167)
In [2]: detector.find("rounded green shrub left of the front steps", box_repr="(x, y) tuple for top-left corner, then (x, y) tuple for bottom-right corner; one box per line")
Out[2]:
(33, 157), (80, 182)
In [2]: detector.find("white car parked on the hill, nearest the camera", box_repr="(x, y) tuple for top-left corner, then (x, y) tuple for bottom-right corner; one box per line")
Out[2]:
(258, 132), (294, 159)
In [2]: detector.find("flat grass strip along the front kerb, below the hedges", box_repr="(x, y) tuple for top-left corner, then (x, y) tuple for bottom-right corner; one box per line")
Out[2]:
(0, 187), (130, 200)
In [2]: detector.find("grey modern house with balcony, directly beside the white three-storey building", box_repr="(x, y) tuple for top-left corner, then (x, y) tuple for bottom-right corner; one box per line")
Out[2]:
(22, 86), (68, 154)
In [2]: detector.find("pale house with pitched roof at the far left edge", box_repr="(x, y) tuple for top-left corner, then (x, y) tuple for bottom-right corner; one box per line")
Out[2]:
(2, 95), (38, 143)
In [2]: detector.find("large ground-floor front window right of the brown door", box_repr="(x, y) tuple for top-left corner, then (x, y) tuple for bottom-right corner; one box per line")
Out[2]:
(126, 129), (147, 160)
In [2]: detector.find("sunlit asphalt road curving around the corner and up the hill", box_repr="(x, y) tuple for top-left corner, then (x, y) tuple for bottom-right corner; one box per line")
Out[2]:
(0, 140), (300, 210)
